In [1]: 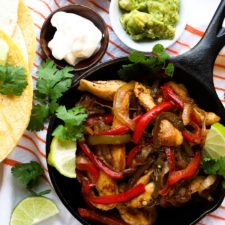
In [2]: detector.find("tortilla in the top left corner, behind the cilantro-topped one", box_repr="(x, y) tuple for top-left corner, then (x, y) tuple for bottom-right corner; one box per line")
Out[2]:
(0, 0), (36, 71)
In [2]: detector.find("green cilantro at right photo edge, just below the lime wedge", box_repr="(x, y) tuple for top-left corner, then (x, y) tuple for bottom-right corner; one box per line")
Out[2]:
(202, 156), (225, 188)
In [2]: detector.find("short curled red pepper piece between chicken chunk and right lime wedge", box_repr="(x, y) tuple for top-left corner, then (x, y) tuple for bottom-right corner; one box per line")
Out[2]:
(182, 122), (202, 144)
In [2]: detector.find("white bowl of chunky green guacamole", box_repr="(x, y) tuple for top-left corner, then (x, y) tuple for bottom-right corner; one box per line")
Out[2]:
(109, 0), (188, 53)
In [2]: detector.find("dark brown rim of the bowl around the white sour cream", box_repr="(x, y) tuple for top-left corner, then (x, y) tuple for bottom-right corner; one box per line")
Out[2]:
(40, 4), (109, 72)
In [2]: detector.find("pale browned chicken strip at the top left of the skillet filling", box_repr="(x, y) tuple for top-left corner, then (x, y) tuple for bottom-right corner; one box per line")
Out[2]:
(78, 79), (125, 101)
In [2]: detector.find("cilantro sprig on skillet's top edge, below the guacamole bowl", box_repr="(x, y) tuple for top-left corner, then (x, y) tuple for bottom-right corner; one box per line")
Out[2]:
(118, 44), (174, 80)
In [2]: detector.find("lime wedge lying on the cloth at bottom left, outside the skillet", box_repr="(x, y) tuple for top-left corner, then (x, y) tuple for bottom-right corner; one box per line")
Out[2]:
(10, 197), (59, 225)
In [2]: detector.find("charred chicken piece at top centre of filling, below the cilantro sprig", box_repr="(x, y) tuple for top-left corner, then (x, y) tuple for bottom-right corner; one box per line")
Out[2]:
(134, 82), (155, 111)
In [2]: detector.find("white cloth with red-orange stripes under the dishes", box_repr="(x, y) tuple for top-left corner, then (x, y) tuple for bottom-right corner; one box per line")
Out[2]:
(0, 0), (225, 225)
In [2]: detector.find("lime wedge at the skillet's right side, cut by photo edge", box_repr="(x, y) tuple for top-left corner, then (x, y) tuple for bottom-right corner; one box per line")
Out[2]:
(204, 123), (225, 159)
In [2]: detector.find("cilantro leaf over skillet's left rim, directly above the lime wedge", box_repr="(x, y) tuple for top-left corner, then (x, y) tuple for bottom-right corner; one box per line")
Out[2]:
(52, 105), (87, 141)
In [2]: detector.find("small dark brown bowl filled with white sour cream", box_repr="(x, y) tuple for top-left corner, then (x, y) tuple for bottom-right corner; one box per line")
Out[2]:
(40, 5), (109, 71)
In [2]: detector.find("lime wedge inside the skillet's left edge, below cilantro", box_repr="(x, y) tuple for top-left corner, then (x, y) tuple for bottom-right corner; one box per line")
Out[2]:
(48, 137), (77, 178)
